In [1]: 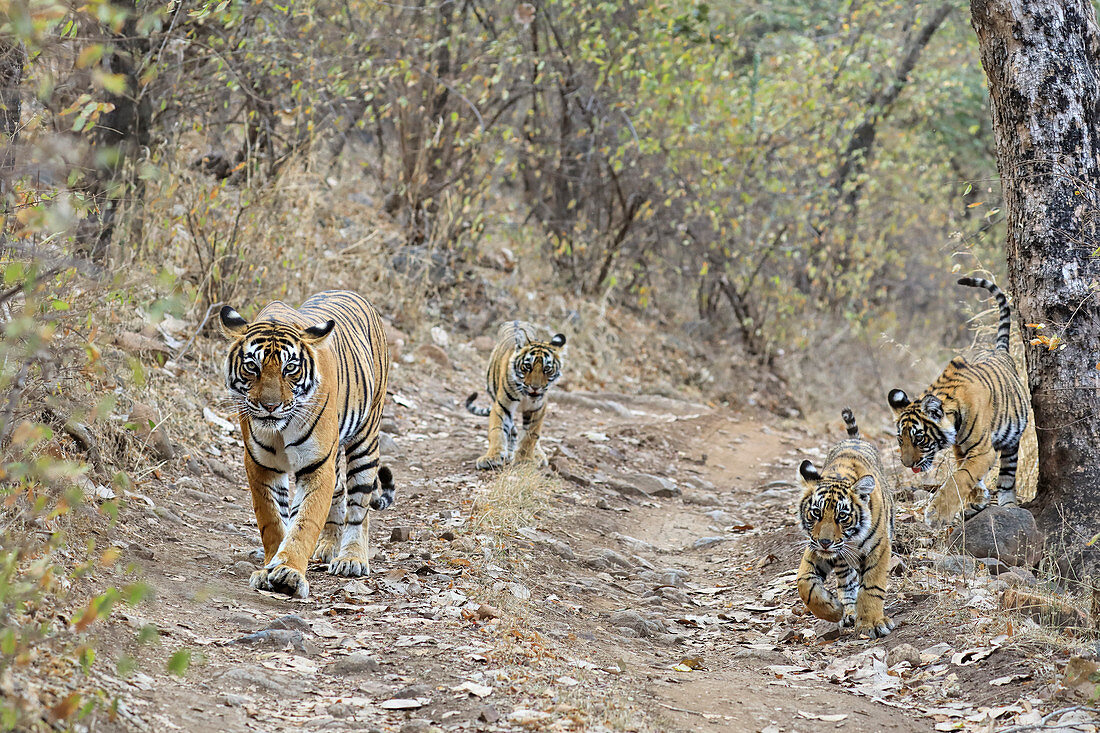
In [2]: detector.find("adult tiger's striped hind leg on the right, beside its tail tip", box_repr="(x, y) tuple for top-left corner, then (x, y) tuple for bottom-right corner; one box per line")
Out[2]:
(329, 426), (380, 578)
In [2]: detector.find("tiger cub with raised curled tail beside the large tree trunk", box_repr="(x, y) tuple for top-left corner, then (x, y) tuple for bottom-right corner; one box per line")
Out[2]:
(887, 277), (1027, 526)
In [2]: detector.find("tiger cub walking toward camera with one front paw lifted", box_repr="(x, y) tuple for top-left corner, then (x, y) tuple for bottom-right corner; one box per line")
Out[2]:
(799, 408), (894, 637)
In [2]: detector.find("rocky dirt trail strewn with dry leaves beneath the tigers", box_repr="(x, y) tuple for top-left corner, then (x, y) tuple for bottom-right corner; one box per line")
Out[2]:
(99, 347), (1056, 733)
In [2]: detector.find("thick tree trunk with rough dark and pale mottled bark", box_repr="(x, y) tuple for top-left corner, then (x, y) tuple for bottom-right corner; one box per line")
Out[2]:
(970, 0), (1100, 557)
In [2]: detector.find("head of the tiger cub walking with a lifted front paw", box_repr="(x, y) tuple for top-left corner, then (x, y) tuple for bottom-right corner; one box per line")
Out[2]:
(799, 461), (875, 559)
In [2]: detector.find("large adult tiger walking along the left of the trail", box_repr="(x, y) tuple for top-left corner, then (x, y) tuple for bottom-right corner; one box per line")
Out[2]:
(221, 291), (394, 598)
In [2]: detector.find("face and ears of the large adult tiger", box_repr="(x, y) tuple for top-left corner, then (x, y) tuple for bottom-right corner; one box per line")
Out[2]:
(221, 306), (336, 433)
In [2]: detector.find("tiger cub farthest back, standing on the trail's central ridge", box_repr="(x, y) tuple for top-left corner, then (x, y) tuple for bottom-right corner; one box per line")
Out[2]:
(466, 320), (565, 469)
